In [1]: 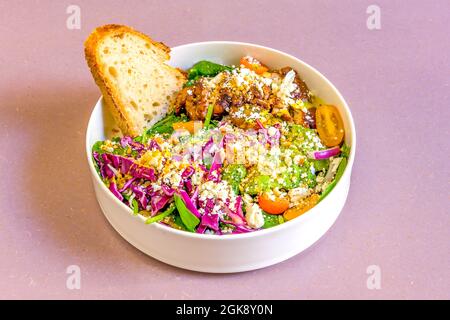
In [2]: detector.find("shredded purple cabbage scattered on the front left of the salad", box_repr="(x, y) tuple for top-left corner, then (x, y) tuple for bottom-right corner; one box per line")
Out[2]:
(93, 132), (264, 235)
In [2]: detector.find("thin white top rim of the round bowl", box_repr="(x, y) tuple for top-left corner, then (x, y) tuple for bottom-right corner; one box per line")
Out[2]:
(85, 41), (356, 241)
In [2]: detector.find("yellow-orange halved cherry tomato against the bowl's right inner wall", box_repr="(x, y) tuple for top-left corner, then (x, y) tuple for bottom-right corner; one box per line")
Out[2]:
(316, 105), (344, 147)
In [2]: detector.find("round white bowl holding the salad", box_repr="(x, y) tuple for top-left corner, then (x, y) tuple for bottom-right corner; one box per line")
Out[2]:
(86, 41), (356, 273)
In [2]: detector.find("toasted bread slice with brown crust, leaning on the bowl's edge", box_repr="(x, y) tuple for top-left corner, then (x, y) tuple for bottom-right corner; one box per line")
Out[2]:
(85, 25), (186, 136)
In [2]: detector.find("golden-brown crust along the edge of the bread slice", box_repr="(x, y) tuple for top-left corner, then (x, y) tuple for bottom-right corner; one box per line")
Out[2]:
(84, 24), (185, 136)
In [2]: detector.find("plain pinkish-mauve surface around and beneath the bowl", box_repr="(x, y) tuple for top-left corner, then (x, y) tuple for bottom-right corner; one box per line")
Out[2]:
(0, 0), (450, 299)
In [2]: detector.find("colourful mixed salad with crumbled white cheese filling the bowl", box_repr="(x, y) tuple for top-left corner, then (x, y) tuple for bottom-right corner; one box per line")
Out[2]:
(92, 56), (350, 235)
